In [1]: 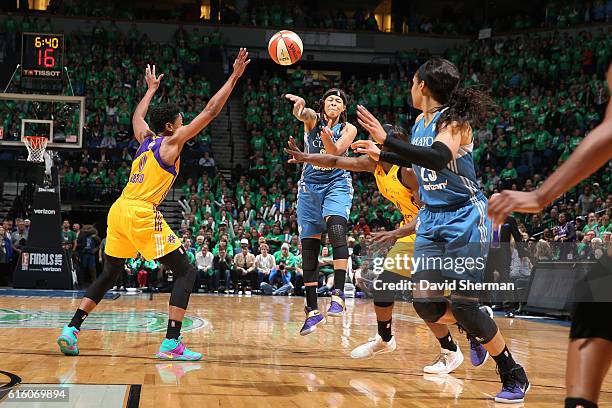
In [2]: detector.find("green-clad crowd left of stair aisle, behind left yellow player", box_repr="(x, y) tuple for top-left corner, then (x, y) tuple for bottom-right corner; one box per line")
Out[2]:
(0, 16), (221, 201)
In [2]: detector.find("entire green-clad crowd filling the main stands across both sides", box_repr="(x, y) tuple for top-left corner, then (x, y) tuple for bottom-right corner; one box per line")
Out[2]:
(0, 12), (612, 294)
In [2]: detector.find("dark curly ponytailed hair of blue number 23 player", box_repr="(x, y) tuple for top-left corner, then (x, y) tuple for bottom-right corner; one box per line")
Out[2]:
(416, 58), (493, 129)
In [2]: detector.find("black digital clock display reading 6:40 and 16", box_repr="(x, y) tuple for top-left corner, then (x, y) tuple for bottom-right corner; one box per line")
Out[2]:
(21, 33), (64, 79)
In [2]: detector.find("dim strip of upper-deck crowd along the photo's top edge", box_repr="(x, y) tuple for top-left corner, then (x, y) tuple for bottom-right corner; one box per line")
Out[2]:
(4, 0), (612, 35)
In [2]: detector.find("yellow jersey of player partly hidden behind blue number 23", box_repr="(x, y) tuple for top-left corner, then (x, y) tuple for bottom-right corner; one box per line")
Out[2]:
(374, 164), (419, 230)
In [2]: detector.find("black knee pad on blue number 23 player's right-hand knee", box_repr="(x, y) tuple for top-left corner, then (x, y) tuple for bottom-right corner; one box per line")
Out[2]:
(451, 298), (497, 344)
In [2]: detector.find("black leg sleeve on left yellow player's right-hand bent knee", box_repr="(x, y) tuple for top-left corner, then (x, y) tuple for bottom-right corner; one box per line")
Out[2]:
(159, 247), (197, 309)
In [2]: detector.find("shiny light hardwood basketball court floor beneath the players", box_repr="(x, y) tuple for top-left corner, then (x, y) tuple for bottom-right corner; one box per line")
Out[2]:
(0, 294), (612, 408)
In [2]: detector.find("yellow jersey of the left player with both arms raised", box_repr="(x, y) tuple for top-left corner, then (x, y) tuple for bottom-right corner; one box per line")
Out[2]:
(121, 136), (180, 206)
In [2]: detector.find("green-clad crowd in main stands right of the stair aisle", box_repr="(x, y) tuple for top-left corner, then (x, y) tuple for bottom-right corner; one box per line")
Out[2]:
(173, 31), (612, 296)
